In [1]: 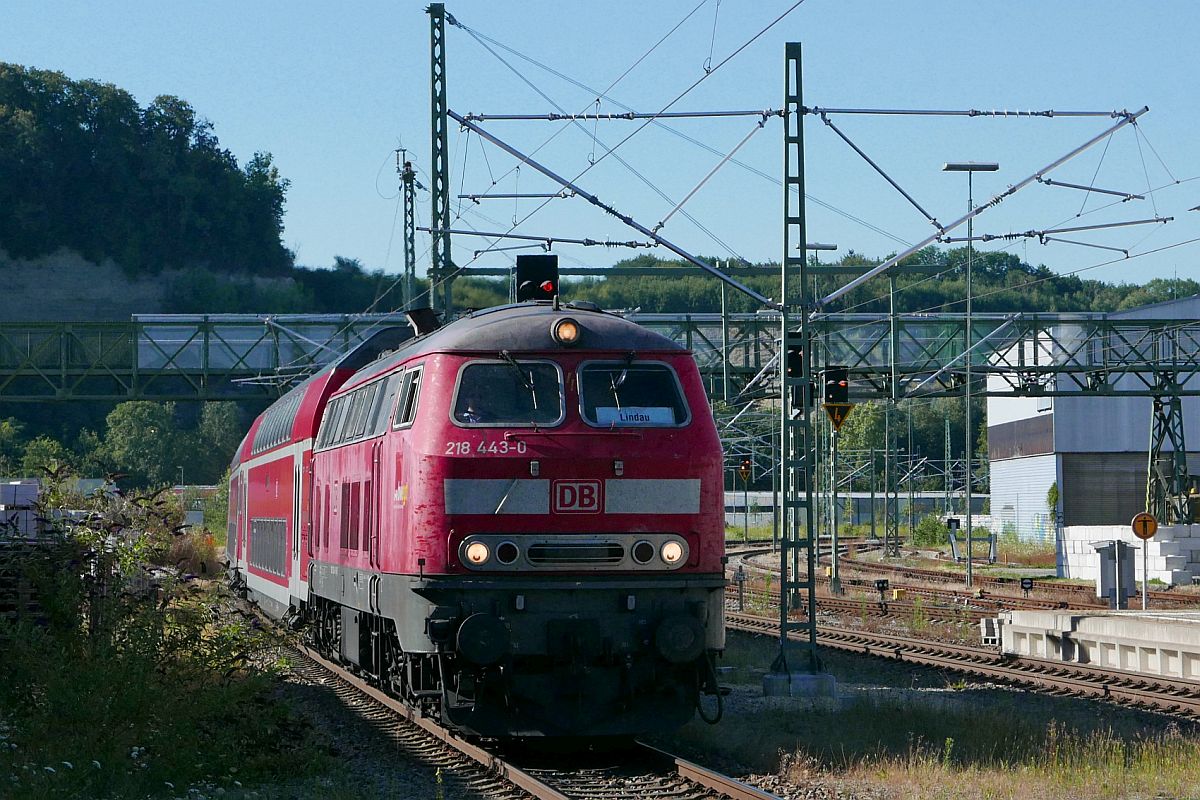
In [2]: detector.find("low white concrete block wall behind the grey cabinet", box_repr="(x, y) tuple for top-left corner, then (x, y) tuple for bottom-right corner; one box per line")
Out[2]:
(1058, 525), (1200, 587)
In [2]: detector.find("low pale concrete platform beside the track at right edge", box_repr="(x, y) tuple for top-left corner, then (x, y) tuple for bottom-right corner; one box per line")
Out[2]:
(998, 610), (1200, 680)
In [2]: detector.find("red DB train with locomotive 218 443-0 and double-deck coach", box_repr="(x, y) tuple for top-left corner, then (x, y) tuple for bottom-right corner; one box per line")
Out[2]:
(229, 301), (725, 736)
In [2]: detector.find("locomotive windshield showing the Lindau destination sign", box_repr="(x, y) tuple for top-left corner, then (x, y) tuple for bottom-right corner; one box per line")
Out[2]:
(580, 362), (688, 427)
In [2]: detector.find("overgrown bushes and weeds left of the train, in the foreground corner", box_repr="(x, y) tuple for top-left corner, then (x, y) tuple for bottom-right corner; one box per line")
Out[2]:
(0, 486), (316, 798)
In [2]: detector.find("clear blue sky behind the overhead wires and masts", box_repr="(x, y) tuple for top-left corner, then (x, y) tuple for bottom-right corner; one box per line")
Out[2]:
(0, 0), (1200, 297)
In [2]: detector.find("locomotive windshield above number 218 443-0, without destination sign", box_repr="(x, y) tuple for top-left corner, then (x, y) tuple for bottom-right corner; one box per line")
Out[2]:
(454, 362), (563, 426)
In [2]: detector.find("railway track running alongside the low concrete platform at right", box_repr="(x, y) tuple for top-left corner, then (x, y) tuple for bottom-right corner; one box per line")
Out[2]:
(726, 613), (1200, 720)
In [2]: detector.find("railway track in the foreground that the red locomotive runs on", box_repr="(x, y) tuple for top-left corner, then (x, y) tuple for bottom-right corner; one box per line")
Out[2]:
(298, 646), (779, 800)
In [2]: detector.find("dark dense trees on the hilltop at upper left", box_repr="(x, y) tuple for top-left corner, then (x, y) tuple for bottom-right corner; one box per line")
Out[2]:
(0, 62), (292, 275)
